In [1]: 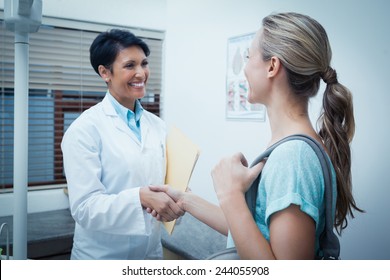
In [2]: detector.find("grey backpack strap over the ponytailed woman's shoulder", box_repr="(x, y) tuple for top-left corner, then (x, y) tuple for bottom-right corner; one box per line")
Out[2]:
(245, 134), (340, 260)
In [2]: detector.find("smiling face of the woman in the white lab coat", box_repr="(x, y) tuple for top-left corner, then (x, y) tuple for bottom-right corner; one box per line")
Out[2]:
(99, 46), (149, 111)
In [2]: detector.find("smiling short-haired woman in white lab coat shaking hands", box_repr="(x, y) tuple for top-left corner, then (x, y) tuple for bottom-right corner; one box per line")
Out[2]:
(61, 29), (184, 259)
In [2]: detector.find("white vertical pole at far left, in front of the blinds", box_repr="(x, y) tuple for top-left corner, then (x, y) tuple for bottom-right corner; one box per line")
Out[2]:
(13, 31), (29, 260)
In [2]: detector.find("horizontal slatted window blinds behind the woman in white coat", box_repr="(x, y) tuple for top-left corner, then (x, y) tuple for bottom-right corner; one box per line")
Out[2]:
(0, 16), (163, 189)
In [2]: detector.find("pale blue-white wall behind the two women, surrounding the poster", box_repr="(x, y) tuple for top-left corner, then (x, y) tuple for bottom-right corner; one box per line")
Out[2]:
(0, 0), (390, 259)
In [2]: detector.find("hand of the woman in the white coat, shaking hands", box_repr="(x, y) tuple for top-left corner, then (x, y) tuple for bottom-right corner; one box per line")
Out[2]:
(140, 187), (184, 222)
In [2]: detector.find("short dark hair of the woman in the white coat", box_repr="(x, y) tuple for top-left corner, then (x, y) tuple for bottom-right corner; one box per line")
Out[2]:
(89, 29), (150, 75)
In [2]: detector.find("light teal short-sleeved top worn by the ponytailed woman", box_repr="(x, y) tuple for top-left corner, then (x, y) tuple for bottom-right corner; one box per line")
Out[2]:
(227, 140), (337, 253)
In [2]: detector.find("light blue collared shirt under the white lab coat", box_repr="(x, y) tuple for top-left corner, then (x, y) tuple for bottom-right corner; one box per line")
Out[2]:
(107, 91), (144, 142)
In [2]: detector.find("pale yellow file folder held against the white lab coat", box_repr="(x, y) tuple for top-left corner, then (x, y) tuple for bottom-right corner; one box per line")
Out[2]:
(164, 127), (200, 234)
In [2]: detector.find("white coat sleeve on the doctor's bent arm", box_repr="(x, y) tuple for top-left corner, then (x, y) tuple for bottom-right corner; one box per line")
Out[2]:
(61, 120), (152, 234)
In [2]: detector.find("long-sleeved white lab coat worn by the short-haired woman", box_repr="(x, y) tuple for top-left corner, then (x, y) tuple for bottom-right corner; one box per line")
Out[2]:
(61, 96), (166, 259)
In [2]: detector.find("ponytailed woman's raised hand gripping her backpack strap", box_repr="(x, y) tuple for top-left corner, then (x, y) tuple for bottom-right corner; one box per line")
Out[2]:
(211, 153), (264, 202)
